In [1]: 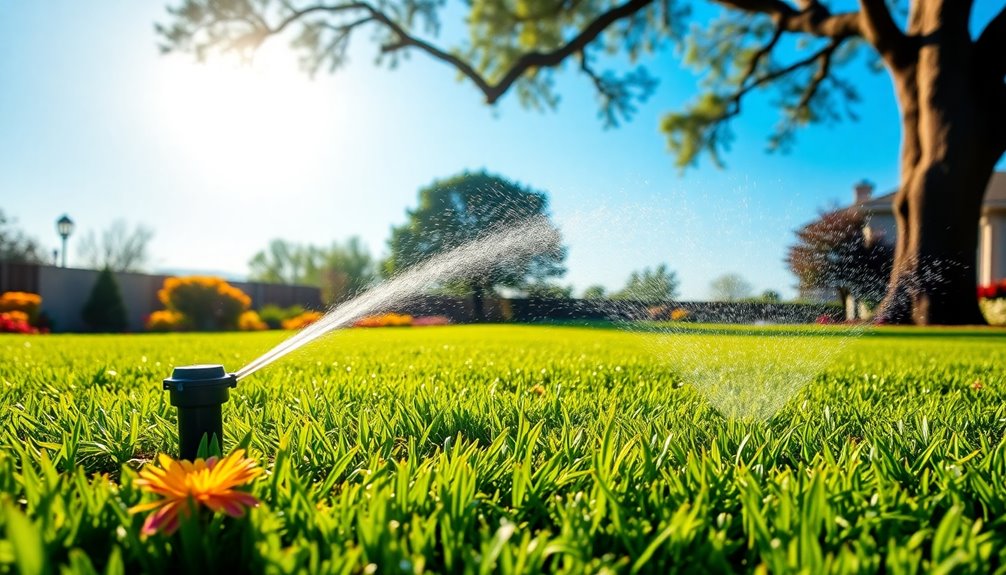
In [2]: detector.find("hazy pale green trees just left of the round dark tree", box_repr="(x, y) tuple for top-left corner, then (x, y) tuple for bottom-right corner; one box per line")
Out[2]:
(248, 236), (377, 304)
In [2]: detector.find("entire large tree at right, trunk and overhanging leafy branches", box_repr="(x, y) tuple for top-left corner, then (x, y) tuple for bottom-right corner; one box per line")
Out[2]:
(158, 0), (1006, 324)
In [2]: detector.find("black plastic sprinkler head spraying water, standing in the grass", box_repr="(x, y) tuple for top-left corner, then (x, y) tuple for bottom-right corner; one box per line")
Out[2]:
(164, 365), (237, 460)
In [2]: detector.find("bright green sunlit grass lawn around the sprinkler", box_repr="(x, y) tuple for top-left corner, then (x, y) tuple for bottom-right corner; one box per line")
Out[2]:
(0, 327), (1006, 573)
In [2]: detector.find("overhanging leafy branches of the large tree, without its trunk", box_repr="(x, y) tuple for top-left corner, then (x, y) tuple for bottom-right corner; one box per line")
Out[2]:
(158, 0), (880, 168)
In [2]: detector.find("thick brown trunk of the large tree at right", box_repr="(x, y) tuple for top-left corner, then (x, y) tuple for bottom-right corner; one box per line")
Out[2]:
(877, 2), (997, 325)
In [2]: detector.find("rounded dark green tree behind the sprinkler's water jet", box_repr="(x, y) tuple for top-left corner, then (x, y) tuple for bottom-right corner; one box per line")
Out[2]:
(384, 171), (565, 322)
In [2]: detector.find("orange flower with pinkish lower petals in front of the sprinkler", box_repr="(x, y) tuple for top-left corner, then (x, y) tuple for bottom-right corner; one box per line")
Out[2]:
(130, 449), (263, 535)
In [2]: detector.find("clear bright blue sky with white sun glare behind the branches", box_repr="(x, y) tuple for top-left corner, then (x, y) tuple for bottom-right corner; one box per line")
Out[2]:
(0, 0), (1001, 299)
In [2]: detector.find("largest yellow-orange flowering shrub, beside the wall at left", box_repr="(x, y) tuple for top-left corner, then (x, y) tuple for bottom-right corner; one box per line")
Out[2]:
(157, 275), (252, 331)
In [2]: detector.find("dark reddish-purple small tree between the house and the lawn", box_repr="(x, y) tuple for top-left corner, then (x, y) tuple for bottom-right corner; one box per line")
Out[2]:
(786, 209), (894, 303)
